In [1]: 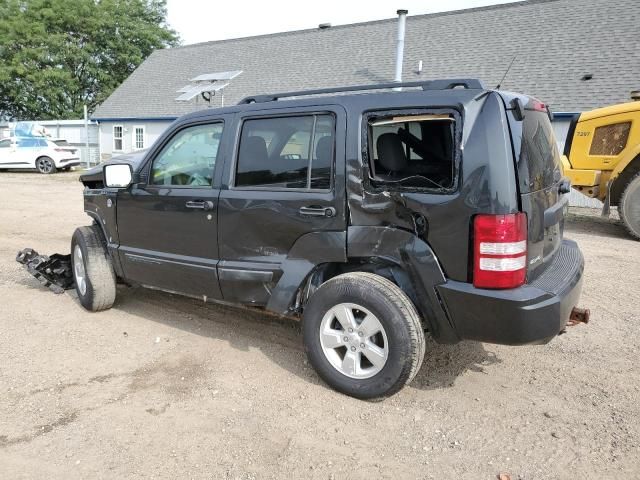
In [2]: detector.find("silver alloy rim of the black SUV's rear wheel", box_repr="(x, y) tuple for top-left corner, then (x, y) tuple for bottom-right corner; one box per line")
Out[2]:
(320, 303), (389, 379)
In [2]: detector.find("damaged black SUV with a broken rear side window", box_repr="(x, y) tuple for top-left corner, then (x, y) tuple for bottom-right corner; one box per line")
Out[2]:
(71, 79), (584, 398)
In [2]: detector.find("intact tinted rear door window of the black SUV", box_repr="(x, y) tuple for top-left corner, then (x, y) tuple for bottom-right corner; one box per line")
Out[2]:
(235, 114), (335, 190)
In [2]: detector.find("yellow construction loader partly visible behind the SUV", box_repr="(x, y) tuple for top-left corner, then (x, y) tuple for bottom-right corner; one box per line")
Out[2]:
(562, 92), (640, 240)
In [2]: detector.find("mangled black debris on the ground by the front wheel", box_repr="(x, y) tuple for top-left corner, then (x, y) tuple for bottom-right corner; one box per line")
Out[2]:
(16, 248), (74, 293)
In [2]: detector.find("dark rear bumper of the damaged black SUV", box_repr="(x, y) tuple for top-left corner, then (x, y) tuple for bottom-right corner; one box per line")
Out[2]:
(436, 240), (584, 345)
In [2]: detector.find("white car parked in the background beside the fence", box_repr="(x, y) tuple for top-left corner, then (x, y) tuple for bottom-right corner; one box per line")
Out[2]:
(0, 137), (80, 173)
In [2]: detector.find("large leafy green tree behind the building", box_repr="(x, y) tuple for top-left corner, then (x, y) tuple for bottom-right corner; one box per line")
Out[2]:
(0, 0), (179, 120)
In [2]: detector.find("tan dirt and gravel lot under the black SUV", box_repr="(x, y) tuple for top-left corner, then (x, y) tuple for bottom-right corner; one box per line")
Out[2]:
(0, 172), (640, 479)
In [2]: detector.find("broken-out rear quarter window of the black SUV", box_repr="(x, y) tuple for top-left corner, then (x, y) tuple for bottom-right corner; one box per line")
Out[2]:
(368, 114), (455, 190)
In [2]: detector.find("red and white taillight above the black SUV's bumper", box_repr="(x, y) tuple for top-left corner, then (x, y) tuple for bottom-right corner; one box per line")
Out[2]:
(473, 213), (527, 288)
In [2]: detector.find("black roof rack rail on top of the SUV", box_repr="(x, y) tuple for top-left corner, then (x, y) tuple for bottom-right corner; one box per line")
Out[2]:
(238, 78), (484, 105)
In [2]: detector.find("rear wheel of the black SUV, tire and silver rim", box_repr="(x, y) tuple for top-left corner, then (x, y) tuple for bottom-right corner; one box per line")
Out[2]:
(302, 272), (425, 399)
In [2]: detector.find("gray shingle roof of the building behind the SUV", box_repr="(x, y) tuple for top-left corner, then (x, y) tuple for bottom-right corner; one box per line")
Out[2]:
(93, 0), (640, 119)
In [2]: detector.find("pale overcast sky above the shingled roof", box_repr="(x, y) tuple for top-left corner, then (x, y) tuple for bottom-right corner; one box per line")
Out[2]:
(167, 0), (509, 45)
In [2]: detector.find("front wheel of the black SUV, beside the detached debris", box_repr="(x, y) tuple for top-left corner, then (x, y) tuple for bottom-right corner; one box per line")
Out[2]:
(71, 225), (116, 312)
